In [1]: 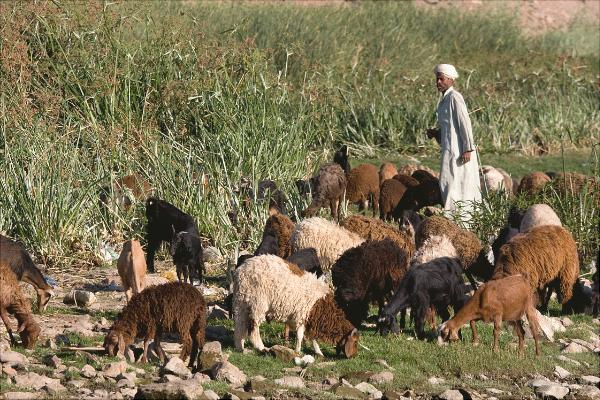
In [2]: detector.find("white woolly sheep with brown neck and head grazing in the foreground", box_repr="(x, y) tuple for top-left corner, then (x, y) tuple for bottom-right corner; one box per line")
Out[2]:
(233, 255), (359, 358)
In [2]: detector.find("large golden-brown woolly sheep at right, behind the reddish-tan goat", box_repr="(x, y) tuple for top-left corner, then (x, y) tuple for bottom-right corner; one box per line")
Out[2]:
(492, 225), (579, 310)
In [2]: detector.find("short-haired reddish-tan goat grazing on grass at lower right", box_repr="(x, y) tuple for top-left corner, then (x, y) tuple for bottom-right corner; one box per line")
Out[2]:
(440, 275), (540, 356)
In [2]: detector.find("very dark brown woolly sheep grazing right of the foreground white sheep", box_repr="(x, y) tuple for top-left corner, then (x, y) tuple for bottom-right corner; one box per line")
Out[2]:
(331, 239), (408, 327)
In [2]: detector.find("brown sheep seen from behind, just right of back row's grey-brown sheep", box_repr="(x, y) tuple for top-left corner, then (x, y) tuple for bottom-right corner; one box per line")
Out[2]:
(346, 164), (379, 216)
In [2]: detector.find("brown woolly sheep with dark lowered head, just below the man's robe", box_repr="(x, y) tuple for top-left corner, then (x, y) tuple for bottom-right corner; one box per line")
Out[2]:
(415, 215), (494, 288)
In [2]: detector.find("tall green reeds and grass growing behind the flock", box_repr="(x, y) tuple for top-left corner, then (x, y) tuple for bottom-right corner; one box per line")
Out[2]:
(0, 1), (600, 267)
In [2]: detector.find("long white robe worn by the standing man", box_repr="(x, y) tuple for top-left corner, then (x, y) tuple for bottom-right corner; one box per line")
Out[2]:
(437, 88), (481, 222)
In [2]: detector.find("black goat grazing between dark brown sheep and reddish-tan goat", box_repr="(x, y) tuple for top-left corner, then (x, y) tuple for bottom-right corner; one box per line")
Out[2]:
(377, 257), (467, 339)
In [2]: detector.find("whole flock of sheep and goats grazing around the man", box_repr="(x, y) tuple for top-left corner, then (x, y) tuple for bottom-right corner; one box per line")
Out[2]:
(0, 147), (600, 376)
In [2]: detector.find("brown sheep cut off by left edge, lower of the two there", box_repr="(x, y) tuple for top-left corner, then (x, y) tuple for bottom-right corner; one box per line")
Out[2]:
(0, 260), (41, 349)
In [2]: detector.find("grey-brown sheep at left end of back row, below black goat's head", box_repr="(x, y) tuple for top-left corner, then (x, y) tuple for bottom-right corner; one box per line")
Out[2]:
(302, 164), (346, 219)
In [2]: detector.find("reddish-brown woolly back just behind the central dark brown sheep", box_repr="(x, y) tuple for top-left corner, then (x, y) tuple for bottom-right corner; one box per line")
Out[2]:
(340, 215), (415, 258)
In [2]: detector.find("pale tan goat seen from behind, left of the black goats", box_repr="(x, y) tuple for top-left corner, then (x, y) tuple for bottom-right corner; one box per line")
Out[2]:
(117, 240), (146, 301)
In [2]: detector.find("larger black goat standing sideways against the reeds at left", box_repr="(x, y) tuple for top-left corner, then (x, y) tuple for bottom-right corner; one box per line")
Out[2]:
(146, 197), (200, 272)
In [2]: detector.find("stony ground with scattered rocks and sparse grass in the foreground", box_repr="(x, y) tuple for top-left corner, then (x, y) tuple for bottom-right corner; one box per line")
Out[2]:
(0, 250), (600, 400)
